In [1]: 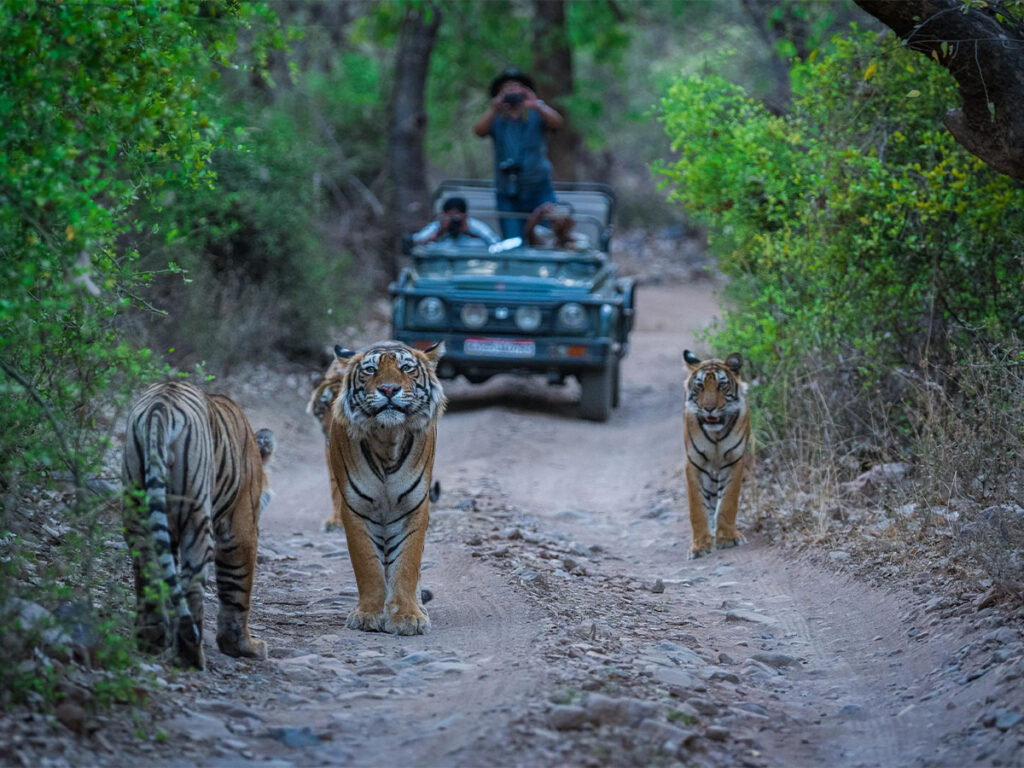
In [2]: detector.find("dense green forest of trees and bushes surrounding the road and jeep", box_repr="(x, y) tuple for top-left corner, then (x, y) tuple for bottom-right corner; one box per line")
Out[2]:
(0, 0), (1024, 716)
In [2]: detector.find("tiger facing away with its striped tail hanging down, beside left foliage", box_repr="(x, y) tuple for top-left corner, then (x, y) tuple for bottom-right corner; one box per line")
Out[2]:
(122, 381), (275, 670)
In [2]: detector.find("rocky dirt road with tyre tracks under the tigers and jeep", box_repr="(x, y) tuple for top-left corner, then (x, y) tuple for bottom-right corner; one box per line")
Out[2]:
(51, 284), (1024, 767)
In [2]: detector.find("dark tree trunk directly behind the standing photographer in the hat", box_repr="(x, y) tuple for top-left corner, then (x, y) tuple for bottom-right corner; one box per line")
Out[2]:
(531, 0), (580, 181)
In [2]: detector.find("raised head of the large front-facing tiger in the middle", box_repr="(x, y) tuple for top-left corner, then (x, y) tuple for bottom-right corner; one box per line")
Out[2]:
(333, 341), (444, 432)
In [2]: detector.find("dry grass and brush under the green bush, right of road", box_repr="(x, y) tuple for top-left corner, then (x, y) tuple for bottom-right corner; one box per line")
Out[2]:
(749, 343), (1024, 599)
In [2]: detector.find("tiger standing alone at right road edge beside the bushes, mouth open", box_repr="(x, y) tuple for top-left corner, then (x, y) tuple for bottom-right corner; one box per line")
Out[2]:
(683, 349), (751, 559)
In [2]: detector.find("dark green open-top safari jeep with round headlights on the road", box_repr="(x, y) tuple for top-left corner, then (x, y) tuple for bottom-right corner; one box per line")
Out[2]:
(389, 181), (635, 421)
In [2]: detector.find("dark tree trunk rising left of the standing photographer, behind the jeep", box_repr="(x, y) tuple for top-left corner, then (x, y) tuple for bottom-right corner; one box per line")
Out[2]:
(384, 3), (441, 278)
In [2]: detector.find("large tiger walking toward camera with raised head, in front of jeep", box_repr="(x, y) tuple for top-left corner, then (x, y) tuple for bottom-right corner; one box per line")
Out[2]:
(328, 341), (445, 635)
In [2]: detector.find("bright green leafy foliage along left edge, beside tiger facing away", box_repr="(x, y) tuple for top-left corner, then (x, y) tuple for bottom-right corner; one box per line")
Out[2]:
(0, 0), (281, 701)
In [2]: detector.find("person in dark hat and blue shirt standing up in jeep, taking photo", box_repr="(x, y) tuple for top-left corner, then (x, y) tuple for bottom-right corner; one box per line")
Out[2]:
(473, 68), (563, 238)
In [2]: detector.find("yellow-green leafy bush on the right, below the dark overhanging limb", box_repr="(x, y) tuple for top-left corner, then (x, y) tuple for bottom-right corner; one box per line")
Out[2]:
(659, 31), (1024, 430)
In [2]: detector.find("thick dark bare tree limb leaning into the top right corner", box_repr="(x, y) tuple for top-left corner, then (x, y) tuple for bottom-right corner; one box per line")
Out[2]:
(855, 0), (1024, 179)
